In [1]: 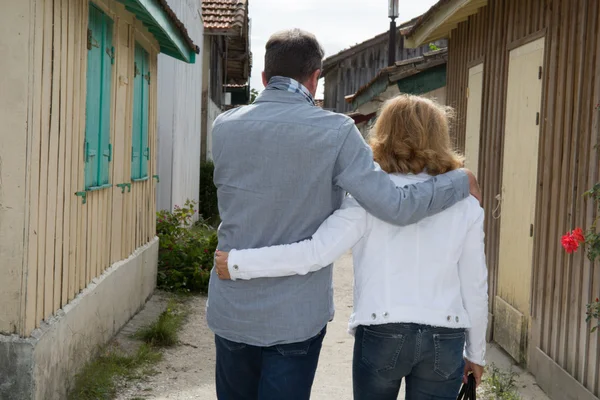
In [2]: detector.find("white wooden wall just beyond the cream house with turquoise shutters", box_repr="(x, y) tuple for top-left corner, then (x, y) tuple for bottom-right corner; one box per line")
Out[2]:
(157, 0), (204, 210)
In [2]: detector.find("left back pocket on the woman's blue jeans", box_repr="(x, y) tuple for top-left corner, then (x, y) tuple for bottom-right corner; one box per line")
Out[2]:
(361, 327), (406, 372)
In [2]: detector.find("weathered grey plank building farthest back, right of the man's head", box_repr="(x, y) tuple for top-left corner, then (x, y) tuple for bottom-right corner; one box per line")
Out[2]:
(321, 19), (446, 113)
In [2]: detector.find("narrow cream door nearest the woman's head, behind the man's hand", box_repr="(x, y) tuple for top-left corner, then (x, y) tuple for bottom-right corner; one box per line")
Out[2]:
(465, 63), (483, 176)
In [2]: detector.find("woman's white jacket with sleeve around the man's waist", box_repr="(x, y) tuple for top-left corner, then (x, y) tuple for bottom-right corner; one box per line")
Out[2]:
(228, 174), (488, 365)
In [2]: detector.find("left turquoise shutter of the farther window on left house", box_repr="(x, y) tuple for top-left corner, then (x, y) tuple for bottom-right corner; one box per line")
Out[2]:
(131, 43), (144, 179)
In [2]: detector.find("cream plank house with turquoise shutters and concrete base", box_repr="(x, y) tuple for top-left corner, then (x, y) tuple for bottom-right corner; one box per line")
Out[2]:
(0, 0), (199, 400)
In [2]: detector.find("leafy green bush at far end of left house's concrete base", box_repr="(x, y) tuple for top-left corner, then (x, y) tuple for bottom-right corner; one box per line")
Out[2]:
(156, 200), (217, 293)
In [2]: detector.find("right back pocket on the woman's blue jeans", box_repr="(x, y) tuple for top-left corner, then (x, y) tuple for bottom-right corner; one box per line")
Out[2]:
(433, 332), (465, 379)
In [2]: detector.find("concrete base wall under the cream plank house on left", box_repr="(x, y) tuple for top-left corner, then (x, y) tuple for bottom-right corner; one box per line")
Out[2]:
(0, 239), (158, 400)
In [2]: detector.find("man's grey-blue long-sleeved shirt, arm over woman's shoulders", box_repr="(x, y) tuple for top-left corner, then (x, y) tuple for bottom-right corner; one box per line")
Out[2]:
(207, 90), (469, 347)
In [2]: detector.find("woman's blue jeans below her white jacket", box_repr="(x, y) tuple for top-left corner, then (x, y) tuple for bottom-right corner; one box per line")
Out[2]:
(352, 324), (465, 400)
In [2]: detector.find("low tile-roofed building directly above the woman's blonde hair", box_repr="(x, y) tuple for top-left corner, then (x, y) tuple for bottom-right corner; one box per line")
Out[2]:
(346, 48), (448, 137)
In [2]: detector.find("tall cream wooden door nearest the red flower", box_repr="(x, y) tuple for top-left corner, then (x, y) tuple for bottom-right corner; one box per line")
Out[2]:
(494, 38), (545, 361)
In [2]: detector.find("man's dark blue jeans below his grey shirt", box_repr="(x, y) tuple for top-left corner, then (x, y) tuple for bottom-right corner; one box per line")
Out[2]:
(215, 328), (326, 400)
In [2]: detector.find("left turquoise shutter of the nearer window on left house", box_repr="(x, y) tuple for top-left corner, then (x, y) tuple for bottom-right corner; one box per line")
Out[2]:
(84, 5), (103, 189)
